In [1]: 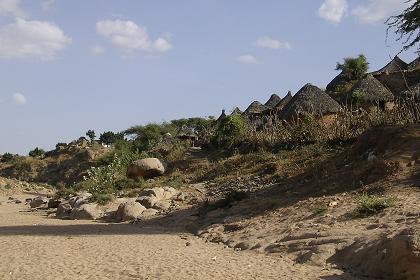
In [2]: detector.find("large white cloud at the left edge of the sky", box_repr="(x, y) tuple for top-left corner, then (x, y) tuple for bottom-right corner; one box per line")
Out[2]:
(0, 19), (71, 60)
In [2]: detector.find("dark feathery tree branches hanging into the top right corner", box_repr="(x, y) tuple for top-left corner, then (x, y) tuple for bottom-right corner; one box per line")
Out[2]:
(386, 0), (420, 55)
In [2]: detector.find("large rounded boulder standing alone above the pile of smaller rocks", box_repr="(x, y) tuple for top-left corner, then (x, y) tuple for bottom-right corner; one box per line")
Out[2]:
(127, 158), (165, 179)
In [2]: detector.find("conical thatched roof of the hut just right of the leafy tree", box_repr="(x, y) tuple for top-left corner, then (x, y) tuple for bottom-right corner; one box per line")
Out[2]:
(350, 75), (394, 102)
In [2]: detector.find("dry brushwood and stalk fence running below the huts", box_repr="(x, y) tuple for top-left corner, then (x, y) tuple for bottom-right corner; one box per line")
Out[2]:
(243, 101), (420, 149)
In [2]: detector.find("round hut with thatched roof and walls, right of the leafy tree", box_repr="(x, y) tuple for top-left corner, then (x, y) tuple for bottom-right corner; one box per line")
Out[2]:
(347, 75), (394, 111)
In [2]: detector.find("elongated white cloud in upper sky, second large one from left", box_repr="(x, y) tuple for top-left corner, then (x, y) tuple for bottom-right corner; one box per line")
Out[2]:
(96, 20), (172, 52)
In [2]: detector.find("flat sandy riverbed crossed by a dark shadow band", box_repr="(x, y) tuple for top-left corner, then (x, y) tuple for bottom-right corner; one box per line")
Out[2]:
(0, 197), (352, 280)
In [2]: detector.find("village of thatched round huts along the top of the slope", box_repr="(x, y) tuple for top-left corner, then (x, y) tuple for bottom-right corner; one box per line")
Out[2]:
(218, 56), (420, 127)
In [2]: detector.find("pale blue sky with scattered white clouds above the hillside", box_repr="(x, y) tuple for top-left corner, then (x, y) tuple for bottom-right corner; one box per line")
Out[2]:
(0, 0), (415, 154)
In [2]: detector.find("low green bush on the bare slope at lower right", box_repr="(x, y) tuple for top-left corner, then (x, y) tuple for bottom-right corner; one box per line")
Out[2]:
(356, 193), (397, 217)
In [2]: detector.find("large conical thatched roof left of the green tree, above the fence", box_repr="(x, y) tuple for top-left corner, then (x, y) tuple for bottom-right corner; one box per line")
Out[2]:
(280, 84), (341, 120)
